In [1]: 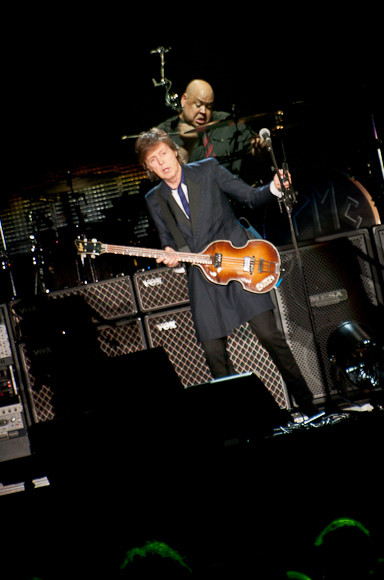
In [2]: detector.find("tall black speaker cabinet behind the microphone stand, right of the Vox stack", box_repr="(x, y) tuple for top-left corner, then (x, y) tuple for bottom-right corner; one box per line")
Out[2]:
(276, 230), (380, 397)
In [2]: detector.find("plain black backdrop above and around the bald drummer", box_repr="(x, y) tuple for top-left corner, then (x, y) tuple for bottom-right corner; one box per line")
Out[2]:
(2, 3), (383, 192)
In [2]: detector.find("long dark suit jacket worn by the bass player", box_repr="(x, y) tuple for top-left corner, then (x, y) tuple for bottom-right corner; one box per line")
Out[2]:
(146, 158), (275, 341)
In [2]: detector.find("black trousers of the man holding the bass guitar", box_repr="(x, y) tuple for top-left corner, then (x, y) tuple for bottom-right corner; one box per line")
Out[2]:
(202, 310), (313, 407)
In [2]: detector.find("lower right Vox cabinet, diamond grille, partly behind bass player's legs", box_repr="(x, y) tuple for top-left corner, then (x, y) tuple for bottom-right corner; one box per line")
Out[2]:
(144, 307), (289, 407)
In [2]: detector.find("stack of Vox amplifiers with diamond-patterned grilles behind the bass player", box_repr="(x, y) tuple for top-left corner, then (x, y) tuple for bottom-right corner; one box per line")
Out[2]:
(12, 267), (288, 423)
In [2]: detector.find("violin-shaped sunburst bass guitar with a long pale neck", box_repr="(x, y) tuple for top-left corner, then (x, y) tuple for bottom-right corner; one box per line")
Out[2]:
(75, 239), (280, 294)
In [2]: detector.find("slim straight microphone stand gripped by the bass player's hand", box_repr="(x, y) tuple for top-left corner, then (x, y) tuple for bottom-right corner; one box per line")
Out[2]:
(266, 138), (333, 410)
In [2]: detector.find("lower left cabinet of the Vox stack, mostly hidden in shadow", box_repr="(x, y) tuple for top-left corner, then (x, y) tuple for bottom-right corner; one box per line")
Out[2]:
(19, 310), (147, 423)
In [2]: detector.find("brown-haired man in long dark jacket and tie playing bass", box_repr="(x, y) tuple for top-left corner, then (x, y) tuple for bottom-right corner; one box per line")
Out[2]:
(136, 128), (319, 416)
